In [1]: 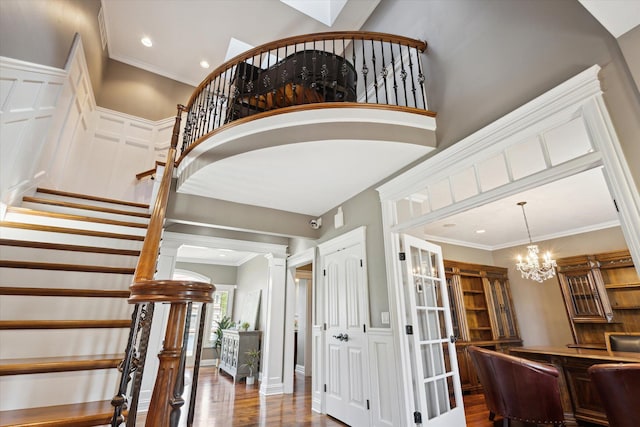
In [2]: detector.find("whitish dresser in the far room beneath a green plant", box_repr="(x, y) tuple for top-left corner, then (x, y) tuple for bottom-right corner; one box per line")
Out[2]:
(219, 329), (262, 383)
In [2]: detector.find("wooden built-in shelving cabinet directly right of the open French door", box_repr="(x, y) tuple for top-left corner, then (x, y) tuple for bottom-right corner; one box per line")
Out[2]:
(444, 260), (522, 391)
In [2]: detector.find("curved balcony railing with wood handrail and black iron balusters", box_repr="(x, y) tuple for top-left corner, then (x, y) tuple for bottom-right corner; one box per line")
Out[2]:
(182, 32), (428, 155)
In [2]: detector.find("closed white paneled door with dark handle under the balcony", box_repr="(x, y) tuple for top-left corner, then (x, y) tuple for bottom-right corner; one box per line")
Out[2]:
(323, 243), (370, 427)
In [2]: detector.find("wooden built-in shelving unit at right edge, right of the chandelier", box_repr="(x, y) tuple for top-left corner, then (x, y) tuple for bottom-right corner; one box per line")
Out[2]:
(556, 250), (640, 348)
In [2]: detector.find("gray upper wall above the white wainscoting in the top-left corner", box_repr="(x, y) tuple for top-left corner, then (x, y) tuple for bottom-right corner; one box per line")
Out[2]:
(0, 0), (108, 94)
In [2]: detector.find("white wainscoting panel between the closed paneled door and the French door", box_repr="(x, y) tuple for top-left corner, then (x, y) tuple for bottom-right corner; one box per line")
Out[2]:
(367, 328), (401, 427)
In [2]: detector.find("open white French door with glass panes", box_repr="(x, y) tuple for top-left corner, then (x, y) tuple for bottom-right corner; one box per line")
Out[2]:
(402, 235), (465, 427)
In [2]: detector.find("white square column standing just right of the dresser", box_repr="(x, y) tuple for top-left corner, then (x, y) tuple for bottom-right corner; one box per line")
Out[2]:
(260, 254), (293, 395)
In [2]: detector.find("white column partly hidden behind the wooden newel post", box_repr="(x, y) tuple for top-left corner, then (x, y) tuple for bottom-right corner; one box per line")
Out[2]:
(138, 244), (175, 413)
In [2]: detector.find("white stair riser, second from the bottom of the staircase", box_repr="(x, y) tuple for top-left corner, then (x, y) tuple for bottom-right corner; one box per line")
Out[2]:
(0, 328), (129, 359)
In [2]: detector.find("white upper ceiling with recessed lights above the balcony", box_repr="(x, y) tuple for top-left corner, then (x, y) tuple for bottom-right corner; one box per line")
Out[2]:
(102, 0), (380, 86)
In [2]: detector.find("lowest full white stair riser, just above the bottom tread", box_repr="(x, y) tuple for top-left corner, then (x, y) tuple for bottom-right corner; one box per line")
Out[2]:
(0, 369), (120, 410)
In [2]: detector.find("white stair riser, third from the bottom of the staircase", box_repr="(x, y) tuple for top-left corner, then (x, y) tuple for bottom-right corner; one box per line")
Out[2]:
(0, 295), (133, 320)
